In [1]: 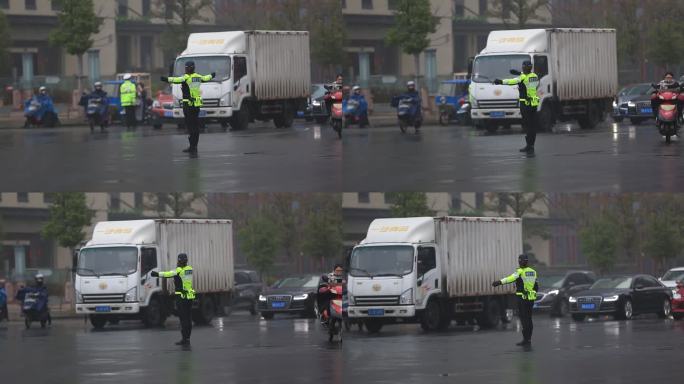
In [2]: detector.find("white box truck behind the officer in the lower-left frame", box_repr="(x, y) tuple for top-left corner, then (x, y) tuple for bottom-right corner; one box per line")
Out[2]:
(74, 220), (233, 328)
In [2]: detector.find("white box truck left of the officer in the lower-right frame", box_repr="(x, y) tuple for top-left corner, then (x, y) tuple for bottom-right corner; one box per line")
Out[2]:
(347, 217), (523, 332)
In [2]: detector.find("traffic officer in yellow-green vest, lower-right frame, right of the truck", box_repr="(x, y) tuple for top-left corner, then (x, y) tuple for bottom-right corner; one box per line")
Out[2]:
(492, 254), (539, 346)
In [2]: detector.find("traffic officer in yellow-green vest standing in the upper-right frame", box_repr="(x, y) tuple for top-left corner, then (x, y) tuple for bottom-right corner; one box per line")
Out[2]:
(494, 60), (539, 156)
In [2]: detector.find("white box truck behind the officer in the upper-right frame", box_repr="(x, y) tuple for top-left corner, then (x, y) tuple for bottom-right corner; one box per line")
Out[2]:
(470, 28), (618, 131)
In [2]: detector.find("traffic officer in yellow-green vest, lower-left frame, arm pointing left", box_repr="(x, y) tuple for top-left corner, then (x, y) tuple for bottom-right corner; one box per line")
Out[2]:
(150, 253), (195, 346)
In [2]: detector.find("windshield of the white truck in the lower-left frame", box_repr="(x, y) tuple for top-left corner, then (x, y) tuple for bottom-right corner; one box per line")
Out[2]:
(76, 247), (138, 276)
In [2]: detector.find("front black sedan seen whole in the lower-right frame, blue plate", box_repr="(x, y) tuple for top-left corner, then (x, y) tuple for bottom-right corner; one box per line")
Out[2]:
(569, 275), (672, 321)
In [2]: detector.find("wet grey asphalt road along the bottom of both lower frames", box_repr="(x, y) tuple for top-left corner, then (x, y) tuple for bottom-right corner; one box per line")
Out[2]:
(0, 314), (684, 384)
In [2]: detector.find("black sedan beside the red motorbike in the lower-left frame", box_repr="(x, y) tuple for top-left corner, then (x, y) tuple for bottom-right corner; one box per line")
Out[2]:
(257, 275), (321, 320)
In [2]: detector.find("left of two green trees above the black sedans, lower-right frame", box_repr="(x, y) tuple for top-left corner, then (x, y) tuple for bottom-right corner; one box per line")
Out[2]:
(579, 216), (617, 274)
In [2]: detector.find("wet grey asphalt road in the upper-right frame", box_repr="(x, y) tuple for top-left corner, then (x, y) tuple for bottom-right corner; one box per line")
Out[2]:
(343, 120), (684, 192)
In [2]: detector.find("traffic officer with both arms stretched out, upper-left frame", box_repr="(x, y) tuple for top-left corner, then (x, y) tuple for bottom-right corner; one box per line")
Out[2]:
(161, 61), (216, 154)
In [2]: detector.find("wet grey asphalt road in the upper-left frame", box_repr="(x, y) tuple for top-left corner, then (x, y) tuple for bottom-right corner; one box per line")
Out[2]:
(0, 121), (342, 192)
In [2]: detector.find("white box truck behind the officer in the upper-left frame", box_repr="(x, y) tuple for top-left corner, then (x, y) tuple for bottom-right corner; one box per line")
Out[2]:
(172, 31), (311, 130)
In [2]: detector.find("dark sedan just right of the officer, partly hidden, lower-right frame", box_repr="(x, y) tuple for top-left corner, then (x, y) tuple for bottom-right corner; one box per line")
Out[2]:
(534, 271), (596, 317)
